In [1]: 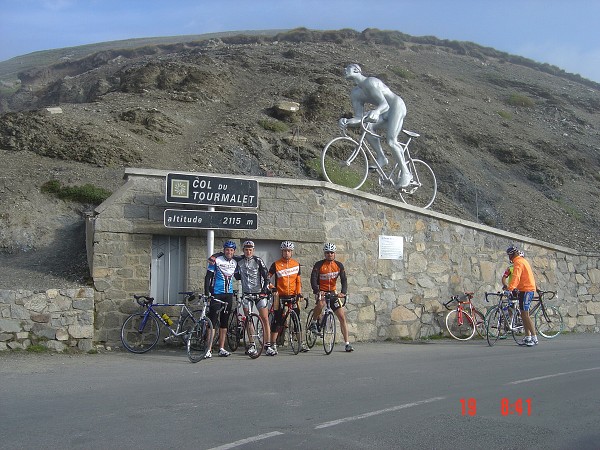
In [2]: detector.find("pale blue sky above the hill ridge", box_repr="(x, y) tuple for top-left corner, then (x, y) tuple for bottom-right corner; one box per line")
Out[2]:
(0, 0), (600, 82)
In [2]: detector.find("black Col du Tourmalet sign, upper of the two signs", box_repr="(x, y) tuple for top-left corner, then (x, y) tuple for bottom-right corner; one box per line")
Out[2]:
(165, 173), (258, 208)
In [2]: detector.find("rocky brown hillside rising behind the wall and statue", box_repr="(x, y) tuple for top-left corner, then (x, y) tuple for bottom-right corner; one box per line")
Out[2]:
(0, 29), (600, 288)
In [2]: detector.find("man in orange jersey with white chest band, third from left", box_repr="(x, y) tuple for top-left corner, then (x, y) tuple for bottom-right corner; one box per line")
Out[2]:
(269, 241), (308, 354)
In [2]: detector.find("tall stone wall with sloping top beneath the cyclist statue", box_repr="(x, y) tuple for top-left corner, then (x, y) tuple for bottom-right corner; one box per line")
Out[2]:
(89, 169), (600, 344)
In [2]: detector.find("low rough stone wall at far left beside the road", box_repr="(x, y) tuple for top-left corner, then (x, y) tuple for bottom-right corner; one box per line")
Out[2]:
(0, 288), (94, 352)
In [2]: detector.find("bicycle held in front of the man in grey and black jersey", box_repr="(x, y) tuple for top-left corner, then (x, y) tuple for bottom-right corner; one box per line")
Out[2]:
(227, 294), (264, 359)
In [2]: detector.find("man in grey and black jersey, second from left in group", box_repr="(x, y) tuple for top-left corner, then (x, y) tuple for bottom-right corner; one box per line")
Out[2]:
(236, 241), (275, 356)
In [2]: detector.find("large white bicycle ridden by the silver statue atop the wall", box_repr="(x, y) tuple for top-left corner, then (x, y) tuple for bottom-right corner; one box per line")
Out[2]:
(321, 116), (437, 208)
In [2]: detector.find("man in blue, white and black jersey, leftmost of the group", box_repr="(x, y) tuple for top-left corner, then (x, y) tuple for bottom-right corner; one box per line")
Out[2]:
(204, 241), (237, 358)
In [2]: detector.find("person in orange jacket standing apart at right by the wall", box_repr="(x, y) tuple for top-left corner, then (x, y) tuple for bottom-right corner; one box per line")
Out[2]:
(506, 245), (538, 347)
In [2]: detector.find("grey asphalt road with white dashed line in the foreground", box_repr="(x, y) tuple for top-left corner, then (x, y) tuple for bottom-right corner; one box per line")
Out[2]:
(0, 334), (600, 449)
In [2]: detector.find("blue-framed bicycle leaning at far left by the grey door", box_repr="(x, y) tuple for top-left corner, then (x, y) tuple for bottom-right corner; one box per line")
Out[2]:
(121, 292), (199, 353)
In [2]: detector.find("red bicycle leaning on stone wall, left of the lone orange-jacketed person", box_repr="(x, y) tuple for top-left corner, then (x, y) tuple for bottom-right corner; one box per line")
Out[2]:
(444, 292), (486, 341)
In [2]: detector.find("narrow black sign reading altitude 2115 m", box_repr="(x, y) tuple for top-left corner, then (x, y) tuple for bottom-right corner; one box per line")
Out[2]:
(164, 209), (258, 230)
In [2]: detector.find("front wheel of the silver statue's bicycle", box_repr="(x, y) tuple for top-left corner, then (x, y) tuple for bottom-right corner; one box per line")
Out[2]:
(321, 136), (369, 189)
